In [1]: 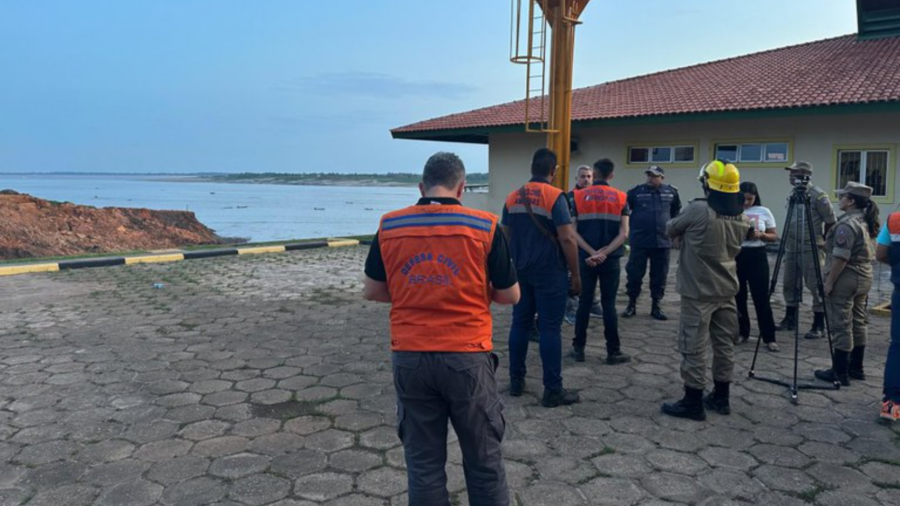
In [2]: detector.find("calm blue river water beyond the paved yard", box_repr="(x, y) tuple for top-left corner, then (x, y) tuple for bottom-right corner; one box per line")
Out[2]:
(0, 174), (419, 242)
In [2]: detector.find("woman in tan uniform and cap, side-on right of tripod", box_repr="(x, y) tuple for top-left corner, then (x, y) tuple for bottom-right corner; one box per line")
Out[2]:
(815, 181), (879, 386)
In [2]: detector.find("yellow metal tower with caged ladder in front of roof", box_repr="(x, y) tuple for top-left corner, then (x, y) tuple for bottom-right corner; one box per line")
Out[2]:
(510, 0), (590, 191)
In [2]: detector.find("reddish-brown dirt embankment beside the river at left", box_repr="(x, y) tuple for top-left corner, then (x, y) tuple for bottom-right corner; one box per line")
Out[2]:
(0, 190), (223, 260)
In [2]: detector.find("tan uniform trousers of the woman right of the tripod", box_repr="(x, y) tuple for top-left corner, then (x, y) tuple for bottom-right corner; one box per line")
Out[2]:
(825, 269), (872, 352)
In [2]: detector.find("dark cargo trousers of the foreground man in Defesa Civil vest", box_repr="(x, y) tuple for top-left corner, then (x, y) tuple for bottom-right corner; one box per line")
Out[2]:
(392, 351), (509, 506)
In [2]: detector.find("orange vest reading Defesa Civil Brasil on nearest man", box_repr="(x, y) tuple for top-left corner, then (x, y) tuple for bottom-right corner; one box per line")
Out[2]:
(378, 205), (497, 352)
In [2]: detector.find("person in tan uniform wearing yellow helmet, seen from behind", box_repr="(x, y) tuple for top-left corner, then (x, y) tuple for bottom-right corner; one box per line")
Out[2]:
(662, 160), (750, 420)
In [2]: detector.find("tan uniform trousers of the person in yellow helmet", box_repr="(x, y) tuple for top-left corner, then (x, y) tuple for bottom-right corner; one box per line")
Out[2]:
(678, 296), (738, 390)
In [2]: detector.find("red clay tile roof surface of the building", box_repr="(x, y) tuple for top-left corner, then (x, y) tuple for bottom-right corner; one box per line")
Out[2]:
(391, 35), (900, 134)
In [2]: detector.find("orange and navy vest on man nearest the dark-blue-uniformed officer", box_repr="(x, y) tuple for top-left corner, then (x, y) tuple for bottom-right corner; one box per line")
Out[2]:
(575, 181), (628, 257)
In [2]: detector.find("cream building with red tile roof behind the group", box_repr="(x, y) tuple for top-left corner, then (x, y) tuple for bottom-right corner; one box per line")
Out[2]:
(391, 11), (900, 220)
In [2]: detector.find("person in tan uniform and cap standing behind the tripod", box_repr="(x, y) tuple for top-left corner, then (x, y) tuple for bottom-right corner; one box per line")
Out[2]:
(775, 160), (835, 339)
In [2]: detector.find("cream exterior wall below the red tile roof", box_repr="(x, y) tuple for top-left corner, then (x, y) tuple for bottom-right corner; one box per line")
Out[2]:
(474, 113), (900, 227)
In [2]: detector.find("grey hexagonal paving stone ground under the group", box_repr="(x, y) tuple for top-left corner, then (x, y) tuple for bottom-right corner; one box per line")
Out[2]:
(0, 246), (900, 506)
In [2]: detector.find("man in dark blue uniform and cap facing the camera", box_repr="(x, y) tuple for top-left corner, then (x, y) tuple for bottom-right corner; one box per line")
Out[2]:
(622, 165), (681, 320)
